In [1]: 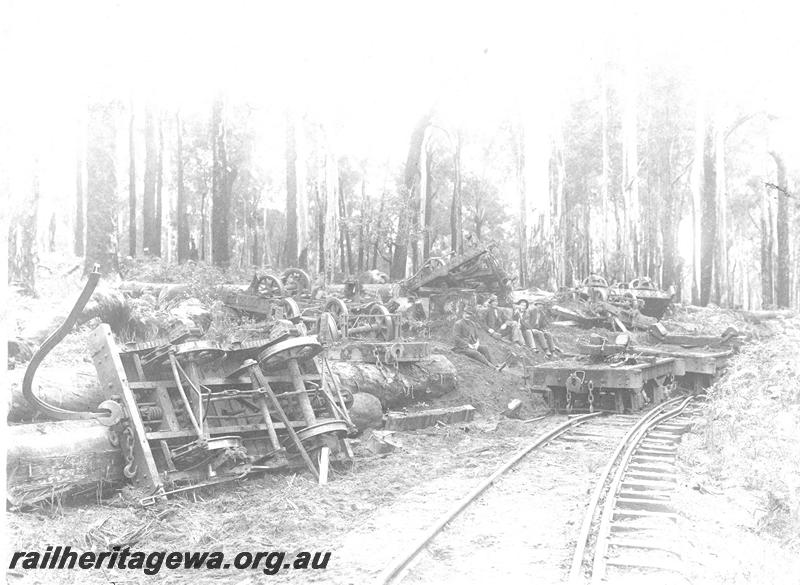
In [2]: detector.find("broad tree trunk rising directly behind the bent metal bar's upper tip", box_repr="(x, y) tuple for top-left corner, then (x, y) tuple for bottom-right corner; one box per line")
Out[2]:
(84, 103), (118, 274)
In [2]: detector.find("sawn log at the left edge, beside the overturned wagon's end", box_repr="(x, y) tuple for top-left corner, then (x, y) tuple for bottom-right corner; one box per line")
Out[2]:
(6, 420), (124, 508)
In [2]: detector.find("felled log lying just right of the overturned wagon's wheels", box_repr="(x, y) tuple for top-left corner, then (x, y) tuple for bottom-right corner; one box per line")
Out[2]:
(328, 355), (457, 409)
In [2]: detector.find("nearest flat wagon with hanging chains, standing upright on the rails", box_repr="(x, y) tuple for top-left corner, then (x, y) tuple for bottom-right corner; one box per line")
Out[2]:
(525, 357), (684, 413)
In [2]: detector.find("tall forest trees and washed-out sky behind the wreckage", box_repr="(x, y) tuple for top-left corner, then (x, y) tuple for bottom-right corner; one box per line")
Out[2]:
(6, 2), (800, 309)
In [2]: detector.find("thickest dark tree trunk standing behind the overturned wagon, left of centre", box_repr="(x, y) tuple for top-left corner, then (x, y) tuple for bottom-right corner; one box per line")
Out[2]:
(211, 96), (231, 267)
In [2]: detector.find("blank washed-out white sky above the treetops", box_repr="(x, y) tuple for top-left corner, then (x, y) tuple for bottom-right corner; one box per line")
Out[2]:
(0, 0), (800, 217)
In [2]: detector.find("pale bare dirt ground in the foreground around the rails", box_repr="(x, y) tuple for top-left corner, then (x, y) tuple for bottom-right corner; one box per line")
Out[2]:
(6, 263), (800, 584)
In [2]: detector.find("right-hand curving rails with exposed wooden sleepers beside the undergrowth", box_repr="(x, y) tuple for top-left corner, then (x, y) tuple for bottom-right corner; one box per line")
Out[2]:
(569, 397), (693, 585)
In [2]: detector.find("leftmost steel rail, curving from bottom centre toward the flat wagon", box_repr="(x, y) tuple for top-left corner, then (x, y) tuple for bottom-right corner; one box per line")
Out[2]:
(376, 412), (603, 585)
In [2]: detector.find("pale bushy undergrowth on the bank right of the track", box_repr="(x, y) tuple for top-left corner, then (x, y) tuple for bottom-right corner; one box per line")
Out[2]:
(705, 319), (800, 546)
